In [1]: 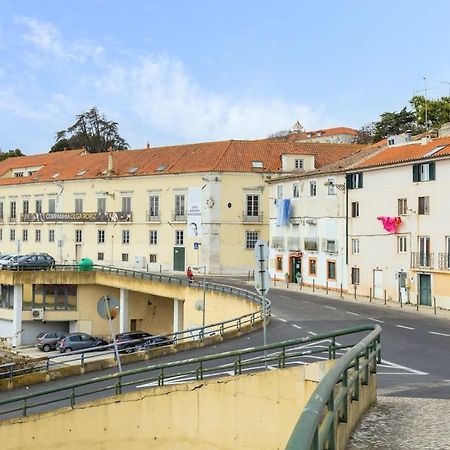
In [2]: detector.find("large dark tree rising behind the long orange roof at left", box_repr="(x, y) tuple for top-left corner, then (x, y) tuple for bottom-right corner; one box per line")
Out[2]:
(50, 106), (130, 153)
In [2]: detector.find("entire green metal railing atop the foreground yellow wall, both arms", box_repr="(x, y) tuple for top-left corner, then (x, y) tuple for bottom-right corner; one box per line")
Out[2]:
(0, 325), (381, 422)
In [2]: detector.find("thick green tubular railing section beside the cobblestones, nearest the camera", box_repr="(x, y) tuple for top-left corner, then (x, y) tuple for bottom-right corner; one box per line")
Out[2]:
(286, 325), (381, 450)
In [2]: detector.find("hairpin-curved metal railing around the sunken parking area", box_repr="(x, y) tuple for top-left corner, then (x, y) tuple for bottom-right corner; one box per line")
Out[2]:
(0, 264), (271, 379)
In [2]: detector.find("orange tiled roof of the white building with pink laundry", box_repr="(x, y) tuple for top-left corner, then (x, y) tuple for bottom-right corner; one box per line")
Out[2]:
(354, 137), (450, 169)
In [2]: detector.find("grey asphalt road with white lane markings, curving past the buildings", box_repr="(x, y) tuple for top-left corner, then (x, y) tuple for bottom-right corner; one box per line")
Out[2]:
(2, 279), (450, 420)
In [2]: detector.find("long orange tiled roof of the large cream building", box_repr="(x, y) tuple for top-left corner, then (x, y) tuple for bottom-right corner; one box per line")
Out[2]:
(0, 139), (363, 185)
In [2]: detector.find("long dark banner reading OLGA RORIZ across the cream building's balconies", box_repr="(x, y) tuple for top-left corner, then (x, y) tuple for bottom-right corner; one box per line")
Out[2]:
(21, 211), (132, 222)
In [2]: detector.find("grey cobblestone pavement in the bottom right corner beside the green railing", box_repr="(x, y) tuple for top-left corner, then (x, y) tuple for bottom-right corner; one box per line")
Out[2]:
(347, 396), (450, 450)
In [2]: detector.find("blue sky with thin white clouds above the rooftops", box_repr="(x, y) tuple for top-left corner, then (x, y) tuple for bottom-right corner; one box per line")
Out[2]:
(0, 0), (450, 154)
